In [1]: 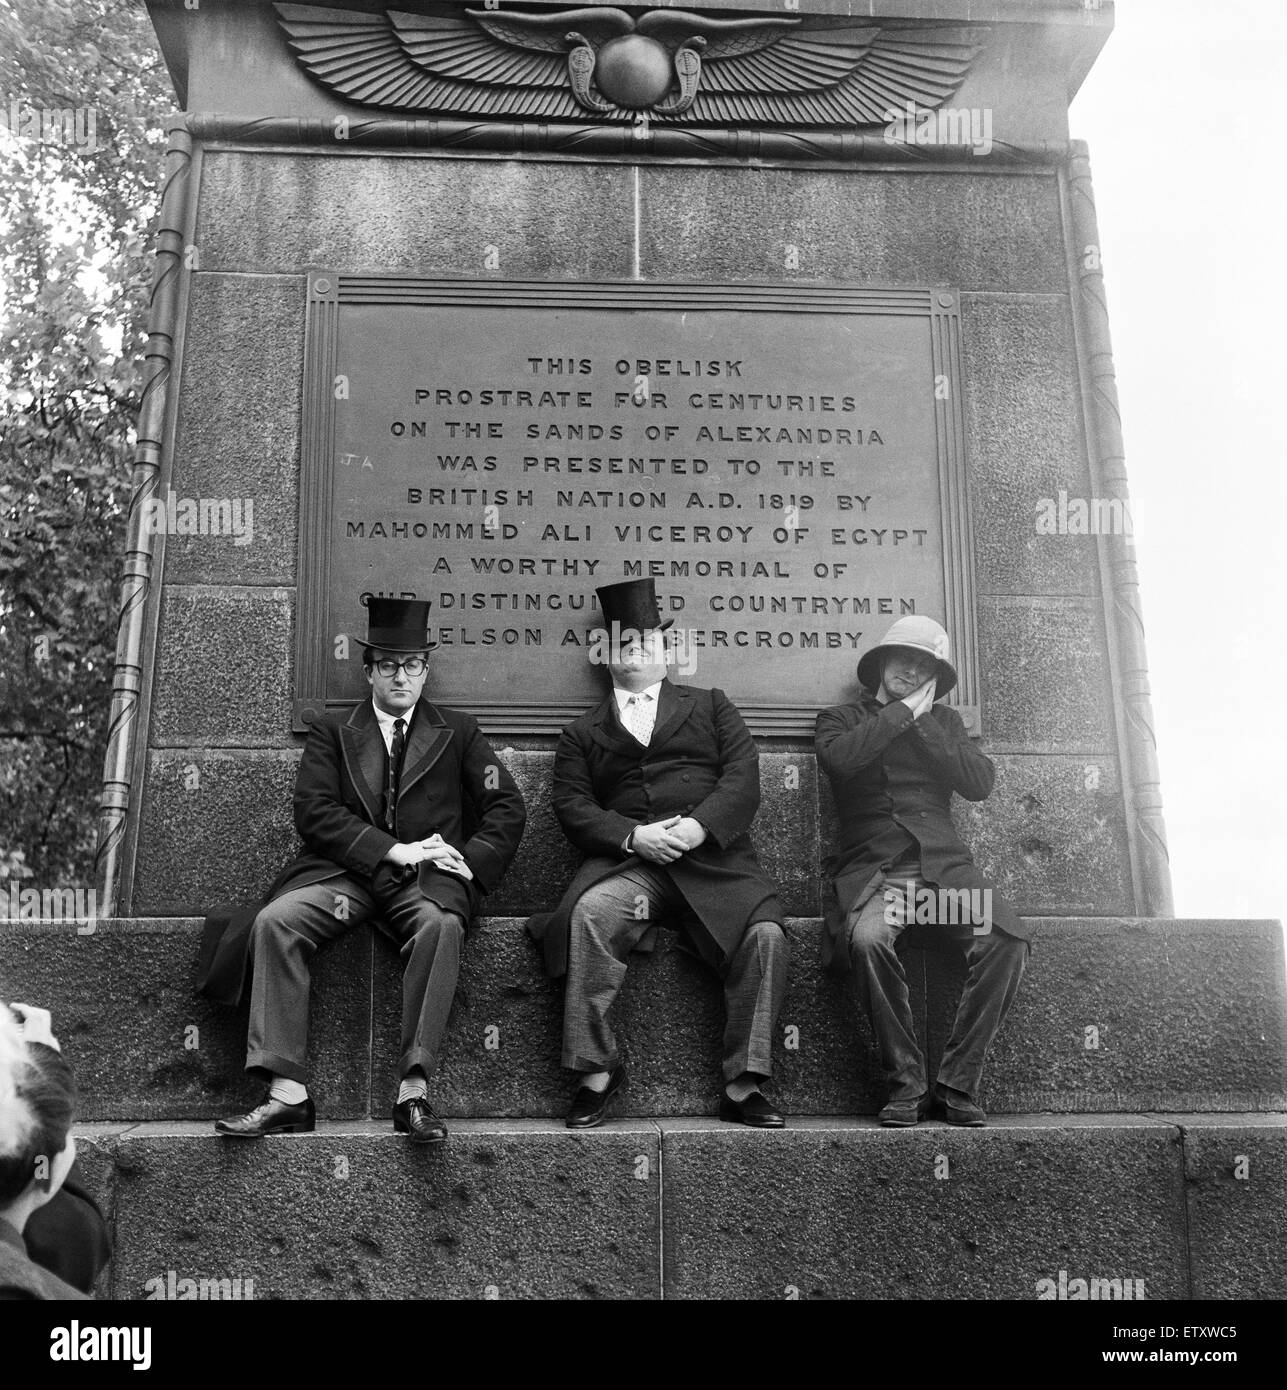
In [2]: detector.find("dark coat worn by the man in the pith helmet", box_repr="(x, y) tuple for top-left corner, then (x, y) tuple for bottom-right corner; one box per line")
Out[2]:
(813, 691), (1026, 970)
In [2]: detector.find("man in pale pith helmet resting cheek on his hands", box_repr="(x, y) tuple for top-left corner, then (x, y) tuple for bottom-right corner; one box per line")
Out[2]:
(814, 616), (1028, 1127)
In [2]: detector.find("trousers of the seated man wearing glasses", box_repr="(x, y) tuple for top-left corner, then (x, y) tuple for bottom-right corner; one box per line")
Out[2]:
(246, 874), (464, 1081)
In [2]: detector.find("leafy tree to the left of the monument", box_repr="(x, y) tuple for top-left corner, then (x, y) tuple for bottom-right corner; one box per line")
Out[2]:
(0, 0), (174, 885)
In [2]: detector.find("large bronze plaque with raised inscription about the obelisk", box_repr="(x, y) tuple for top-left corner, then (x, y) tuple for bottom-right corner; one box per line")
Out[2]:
(296, 274), (978, 735)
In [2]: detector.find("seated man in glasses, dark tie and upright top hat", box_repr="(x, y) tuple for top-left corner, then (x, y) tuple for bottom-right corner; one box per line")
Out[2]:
(204, 598), (525, 1143)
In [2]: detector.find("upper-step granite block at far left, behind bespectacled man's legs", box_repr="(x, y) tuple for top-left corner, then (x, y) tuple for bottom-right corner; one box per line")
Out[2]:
(0, 917), (371, 1120)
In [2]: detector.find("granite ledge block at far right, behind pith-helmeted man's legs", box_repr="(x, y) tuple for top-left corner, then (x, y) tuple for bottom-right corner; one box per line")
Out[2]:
(927, 917), (1287, 1113)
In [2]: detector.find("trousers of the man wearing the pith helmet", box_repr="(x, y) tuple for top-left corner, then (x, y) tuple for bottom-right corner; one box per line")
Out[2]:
(849, 865), (1028, 1102)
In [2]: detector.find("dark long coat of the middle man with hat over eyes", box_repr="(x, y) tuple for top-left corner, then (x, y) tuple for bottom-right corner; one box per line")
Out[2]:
(527, 681), (782, 976)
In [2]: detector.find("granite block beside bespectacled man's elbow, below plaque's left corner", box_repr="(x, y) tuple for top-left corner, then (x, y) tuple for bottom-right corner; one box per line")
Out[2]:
(132, 748), (299, 916)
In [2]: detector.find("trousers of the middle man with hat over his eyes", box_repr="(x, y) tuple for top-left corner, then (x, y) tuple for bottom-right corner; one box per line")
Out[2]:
(563, 863), (791, 1081)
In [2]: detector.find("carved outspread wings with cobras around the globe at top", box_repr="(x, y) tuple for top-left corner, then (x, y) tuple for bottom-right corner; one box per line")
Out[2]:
(275, 3), (987, 128)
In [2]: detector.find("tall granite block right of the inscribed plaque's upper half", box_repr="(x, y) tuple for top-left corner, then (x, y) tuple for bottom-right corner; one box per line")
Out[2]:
(960, 293), (1099, 596)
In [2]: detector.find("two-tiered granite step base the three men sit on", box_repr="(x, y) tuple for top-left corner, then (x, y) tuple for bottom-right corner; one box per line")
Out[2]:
(0, 917), (1287, 1300)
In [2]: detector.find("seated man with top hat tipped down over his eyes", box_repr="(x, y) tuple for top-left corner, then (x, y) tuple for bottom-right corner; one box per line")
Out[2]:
(528, 580), (788, 1129)
